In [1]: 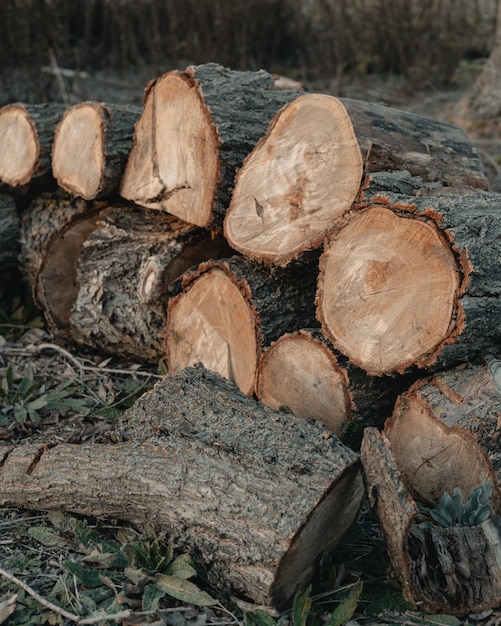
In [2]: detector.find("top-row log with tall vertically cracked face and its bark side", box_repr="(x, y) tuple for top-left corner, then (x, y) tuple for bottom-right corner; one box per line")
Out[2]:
(120, 63), (301, 230)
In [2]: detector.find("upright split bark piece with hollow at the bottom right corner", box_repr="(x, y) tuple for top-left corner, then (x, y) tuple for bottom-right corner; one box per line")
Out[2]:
(361, 426), (501, 615)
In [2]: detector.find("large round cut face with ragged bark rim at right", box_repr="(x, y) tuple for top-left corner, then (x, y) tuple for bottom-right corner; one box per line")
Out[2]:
(317, 204), (460, 374)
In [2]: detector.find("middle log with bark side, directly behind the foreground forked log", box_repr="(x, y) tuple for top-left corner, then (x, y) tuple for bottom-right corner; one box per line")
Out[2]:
(165, 255), (318, 394)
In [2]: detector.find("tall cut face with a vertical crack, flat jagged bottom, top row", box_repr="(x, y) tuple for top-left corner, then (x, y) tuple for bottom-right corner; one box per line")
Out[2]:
(120, 71), (219, 226)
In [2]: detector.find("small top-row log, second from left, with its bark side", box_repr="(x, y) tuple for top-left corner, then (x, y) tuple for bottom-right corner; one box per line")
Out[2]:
(52, 102), (141, 200)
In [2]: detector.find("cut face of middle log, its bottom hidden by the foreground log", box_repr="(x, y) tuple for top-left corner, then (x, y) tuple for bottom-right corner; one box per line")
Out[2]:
(166, 269), (257, 395)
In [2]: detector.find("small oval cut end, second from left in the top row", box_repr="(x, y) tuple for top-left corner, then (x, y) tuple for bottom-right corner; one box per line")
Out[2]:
(52, 102), (105, 199)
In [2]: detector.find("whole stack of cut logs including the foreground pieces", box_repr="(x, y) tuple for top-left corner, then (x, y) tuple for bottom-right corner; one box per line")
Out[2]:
(0, 64), (501, 614)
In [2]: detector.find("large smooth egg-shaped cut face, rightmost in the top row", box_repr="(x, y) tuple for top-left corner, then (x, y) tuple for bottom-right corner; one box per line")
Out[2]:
(224, 94), (362, 265)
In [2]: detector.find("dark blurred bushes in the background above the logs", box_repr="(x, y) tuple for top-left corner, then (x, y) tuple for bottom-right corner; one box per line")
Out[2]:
(0, 0), (495, 101)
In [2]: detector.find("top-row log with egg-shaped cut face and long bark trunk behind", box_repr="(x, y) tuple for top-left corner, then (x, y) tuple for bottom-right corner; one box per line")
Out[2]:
(224, 94), (488, 265)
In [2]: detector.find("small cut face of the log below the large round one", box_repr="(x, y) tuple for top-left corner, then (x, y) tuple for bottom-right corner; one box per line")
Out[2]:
(256, 333), (351, 435)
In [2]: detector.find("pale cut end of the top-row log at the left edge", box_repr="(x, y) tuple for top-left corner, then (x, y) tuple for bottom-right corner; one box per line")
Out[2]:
(0, 104), (40, 187)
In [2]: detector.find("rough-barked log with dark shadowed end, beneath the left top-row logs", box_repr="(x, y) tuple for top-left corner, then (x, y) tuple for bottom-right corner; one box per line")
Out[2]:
(22, 196), (228, 362)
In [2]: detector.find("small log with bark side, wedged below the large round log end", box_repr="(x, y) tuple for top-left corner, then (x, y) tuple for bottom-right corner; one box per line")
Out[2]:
(256, 329), (410, 436)
